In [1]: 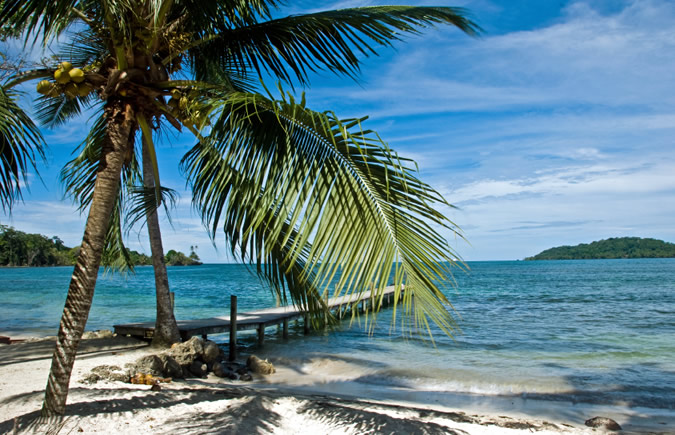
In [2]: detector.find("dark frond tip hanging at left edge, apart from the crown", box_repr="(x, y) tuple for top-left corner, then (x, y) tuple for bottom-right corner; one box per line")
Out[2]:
(0, 86), (46, 210)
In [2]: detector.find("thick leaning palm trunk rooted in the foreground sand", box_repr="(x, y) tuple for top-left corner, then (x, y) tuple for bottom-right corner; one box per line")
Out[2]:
(42, 105), (135, 417)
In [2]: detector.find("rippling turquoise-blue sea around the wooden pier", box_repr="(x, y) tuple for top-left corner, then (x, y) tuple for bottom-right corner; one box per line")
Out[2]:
(0, 259), (675, 418)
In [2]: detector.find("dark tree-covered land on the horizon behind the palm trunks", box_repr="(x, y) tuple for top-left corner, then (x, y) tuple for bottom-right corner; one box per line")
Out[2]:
(0, 225), (202, 267)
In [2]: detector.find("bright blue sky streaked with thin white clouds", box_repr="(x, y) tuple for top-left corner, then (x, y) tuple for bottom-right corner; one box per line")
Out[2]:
(0, 0), (675, 262)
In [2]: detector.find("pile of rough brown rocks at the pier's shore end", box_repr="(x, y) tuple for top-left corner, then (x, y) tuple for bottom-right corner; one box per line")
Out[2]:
(82, 337), (275, 384)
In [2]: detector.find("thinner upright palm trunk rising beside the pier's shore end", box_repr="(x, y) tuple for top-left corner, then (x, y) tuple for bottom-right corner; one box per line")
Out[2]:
(143, 143), (180, 347)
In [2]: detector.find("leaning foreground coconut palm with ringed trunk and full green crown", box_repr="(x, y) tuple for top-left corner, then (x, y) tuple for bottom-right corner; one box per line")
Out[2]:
(0, 0), (478, 415)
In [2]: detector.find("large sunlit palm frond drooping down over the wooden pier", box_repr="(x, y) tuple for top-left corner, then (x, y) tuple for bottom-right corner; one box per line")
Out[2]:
(182, 87), (461, 333)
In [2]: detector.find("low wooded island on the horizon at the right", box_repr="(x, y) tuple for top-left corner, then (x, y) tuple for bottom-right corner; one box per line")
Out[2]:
(525, 237), (675, 260)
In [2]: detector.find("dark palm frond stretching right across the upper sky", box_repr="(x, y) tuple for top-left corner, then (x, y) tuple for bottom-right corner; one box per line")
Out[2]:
(201, 6), (480, 84)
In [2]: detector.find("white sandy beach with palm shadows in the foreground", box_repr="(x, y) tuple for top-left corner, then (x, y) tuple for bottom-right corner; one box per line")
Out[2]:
(0, 337), (667, 434)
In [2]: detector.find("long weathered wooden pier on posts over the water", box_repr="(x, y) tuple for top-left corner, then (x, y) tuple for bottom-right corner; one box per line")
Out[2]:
(113, 286), (403, 353)
